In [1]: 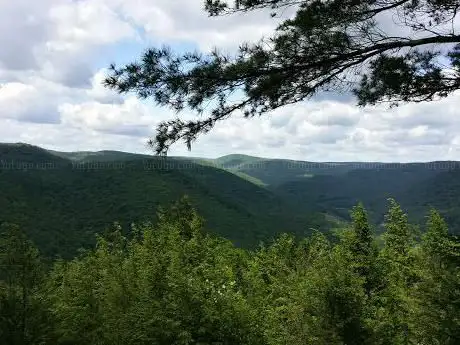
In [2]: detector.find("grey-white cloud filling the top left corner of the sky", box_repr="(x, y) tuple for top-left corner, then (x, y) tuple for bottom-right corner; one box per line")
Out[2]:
(0, 0), (137, 86)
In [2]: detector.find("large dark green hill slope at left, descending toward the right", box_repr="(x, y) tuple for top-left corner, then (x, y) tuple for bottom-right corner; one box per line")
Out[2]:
(0, 145), (325, 256)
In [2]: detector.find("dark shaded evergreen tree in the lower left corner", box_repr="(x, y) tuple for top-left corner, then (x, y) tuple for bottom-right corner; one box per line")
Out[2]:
(0, 224), (50, 345)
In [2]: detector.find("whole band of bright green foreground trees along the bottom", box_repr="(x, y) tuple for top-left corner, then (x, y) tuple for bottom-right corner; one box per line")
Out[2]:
(0, 200), (460, 345)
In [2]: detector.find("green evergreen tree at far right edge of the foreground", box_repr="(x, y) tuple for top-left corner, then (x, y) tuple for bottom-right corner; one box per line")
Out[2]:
(413, 210), (460, 345)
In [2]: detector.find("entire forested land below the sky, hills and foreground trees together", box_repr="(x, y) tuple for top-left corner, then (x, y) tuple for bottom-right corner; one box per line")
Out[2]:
(0, 144), (460, 345)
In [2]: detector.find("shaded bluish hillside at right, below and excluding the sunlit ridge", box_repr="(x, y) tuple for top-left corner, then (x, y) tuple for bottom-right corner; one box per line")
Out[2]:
(272, 162), (460, 231)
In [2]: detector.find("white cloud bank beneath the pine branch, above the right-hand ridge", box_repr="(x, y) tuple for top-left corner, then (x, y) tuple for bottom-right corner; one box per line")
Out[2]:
(172, 96), (460, 161)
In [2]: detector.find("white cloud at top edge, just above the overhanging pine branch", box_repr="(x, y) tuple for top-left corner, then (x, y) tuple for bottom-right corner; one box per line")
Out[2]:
(106, 0), (290, 51)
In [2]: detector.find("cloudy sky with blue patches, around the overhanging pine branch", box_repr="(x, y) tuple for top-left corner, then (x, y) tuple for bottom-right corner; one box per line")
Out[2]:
(0, 0), (460, 162)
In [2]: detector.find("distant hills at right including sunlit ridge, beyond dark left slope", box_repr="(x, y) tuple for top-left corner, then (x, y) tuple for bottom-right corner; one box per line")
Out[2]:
(214, 155), (460, 231)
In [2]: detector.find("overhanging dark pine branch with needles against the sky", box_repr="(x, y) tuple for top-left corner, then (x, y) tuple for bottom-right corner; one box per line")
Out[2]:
(104, 0), (460, 154)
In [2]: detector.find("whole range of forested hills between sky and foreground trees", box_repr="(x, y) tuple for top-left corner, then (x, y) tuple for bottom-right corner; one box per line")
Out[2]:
(0, 144), (460, 255)
